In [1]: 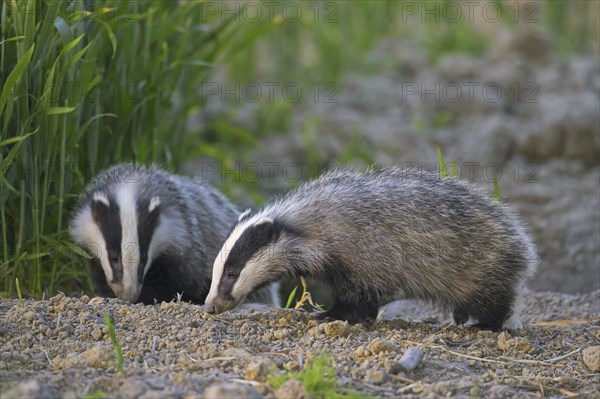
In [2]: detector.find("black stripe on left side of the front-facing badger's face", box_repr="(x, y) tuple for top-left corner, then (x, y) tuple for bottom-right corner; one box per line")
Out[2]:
(92, 198), (123, 282)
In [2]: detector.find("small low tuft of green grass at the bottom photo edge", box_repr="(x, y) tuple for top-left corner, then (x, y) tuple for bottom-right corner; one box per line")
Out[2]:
(268, 356), (369, 399)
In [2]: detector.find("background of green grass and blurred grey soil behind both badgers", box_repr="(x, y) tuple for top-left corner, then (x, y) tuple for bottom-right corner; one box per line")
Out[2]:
(0, 0), (600, 297)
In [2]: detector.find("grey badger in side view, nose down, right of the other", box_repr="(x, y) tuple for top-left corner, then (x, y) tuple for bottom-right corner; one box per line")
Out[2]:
(206, 167), (538, 330)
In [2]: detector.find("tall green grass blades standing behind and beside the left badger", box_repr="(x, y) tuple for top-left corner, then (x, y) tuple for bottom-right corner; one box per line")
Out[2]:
(0, 0), (272, 297)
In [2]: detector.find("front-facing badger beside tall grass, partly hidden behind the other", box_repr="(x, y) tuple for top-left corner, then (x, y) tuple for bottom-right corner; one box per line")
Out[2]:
(69, 164), (279, 306)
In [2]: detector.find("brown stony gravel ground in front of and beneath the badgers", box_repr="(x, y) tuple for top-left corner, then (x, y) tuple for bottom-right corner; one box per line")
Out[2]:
(0, 291), (600, 399)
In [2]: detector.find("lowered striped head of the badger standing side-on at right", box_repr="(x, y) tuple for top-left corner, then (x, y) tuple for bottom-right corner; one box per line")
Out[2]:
(205, 211), (294, 313)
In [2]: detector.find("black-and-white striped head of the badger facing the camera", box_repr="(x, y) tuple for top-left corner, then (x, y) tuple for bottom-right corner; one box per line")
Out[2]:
(69, 184), (165, 302)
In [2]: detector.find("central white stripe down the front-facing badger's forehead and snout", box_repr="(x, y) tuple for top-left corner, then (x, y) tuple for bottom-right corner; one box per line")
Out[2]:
(116, 183), (141, 300)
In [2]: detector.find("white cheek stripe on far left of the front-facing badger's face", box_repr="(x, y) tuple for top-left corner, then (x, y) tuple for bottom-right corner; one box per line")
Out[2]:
(70, 206), (113, 282)
